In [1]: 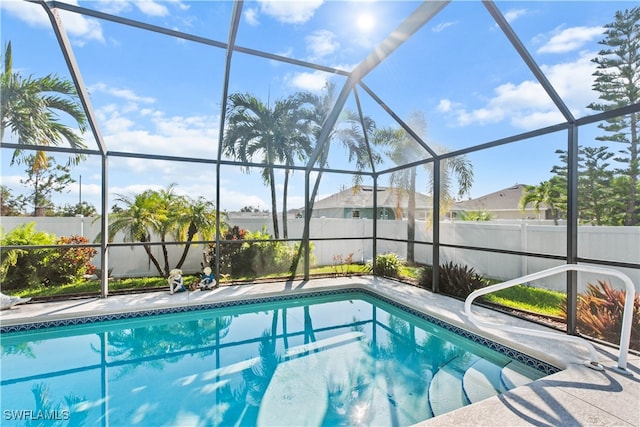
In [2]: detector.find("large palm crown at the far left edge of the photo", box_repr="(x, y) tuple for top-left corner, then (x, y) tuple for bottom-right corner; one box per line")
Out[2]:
(0, 42), (87, 169)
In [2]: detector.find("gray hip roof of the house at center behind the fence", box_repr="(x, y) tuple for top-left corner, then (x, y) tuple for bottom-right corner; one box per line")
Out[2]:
(313, 185), (432, 209)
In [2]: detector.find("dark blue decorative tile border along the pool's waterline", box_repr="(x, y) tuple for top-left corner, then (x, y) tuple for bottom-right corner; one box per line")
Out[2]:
(0, 288), (560, 375)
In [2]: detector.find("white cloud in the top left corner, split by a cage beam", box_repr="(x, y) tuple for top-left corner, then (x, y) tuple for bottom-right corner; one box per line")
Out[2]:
(1, 1), (104, 45)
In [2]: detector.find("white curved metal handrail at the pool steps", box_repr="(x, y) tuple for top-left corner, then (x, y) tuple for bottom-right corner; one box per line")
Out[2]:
(464, 264), (635, 374)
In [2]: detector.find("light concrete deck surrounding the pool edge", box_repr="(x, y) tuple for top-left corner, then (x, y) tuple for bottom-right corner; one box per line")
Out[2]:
(0, 276), (640, 426)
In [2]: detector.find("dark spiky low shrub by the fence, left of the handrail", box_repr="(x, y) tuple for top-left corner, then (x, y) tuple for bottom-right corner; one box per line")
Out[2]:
(418, 261), (485, 298)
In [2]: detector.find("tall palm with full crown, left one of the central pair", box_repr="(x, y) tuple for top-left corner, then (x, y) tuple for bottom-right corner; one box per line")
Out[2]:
(222, 93), (301, 239)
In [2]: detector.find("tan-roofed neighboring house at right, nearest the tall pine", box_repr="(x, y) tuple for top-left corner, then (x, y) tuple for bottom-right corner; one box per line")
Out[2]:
(451, 184), (553, 219)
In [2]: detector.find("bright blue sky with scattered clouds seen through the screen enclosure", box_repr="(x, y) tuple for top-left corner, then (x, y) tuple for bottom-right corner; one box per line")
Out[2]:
(0, 0), (639, 211)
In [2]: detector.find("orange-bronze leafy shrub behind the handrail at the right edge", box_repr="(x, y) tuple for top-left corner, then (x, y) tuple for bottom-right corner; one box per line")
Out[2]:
(562, 280), (640, 350)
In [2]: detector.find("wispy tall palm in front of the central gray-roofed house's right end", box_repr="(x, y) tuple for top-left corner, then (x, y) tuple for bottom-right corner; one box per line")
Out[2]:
(373, 112), (473, 263)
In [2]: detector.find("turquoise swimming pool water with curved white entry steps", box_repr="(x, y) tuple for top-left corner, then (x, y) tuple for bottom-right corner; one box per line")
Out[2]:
(0, 289), (558, 426)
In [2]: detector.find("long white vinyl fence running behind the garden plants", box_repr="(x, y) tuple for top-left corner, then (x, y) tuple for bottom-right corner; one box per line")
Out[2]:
(1, 217), (640, 290)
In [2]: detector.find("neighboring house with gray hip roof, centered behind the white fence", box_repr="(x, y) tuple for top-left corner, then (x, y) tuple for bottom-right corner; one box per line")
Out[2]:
(311, 185), (432, 220)
